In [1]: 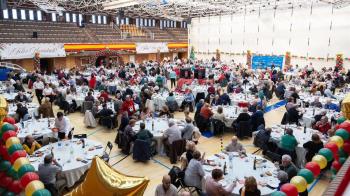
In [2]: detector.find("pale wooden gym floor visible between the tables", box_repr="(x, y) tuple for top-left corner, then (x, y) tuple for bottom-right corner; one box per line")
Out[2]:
(34, 93), (329, 196)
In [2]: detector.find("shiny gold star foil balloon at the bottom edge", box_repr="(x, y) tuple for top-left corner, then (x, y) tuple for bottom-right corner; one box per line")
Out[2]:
(67, 157), (149, 196)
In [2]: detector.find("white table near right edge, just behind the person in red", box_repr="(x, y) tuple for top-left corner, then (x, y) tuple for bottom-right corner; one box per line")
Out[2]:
(303, 107), (340, 127)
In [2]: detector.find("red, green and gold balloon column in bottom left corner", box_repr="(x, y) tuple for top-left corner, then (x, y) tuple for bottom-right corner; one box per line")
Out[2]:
(0, 117), (51, 196)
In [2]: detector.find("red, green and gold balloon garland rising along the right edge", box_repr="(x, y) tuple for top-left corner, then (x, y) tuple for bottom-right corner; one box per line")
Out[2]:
(271, 119), (350, 196)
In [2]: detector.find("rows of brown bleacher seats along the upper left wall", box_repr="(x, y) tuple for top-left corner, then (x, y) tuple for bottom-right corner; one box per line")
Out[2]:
(0, 20), (187, 43)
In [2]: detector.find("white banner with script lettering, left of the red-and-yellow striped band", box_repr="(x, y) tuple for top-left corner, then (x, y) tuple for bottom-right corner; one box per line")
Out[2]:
(0, 43), (66, 60)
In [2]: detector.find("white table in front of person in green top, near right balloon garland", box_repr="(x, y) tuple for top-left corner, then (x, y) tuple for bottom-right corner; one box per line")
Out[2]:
(271, 125), (327, 168)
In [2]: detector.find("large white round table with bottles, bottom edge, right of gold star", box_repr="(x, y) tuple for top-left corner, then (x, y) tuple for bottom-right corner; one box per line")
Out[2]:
(203, 152), (279, 195)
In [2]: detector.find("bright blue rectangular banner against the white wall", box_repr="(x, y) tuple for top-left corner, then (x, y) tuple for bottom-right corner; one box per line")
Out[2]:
(252, 56), (283, 70)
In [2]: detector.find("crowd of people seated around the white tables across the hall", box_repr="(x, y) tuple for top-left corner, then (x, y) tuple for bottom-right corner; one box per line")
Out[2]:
(6, 58), (348, 195)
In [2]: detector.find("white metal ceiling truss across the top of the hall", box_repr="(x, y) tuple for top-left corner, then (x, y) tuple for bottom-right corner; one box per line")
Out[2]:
(9, 0), (350, 21)
